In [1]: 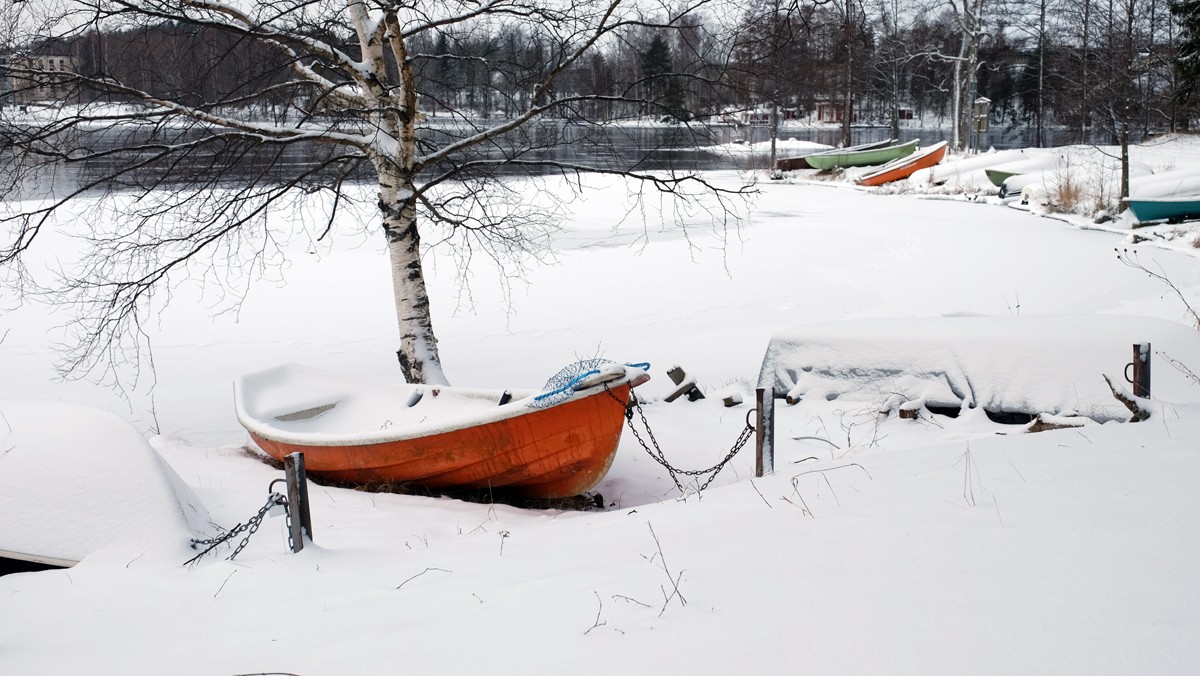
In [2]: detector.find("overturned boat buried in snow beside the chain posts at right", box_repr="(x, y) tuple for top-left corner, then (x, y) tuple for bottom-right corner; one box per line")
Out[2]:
(758, 316), (1200, 421)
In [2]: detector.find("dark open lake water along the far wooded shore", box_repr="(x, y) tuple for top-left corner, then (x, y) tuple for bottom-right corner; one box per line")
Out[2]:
(7, 120), (1104, 197)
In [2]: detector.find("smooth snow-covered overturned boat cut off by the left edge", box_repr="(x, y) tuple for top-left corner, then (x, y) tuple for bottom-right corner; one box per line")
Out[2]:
(0, 399), (215, 574)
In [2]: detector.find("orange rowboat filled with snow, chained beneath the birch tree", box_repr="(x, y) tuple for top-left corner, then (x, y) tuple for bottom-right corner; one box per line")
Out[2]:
(234, 360), (649, 498)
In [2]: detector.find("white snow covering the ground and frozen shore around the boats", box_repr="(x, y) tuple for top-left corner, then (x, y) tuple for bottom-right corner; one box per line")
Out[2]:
(7, 140), (1200, 675)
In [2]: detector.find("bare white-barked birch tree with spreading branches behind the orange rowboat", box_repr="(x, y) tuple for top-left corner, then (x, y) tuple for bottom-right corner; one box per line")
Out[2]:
(0, 0), (744, 383)
